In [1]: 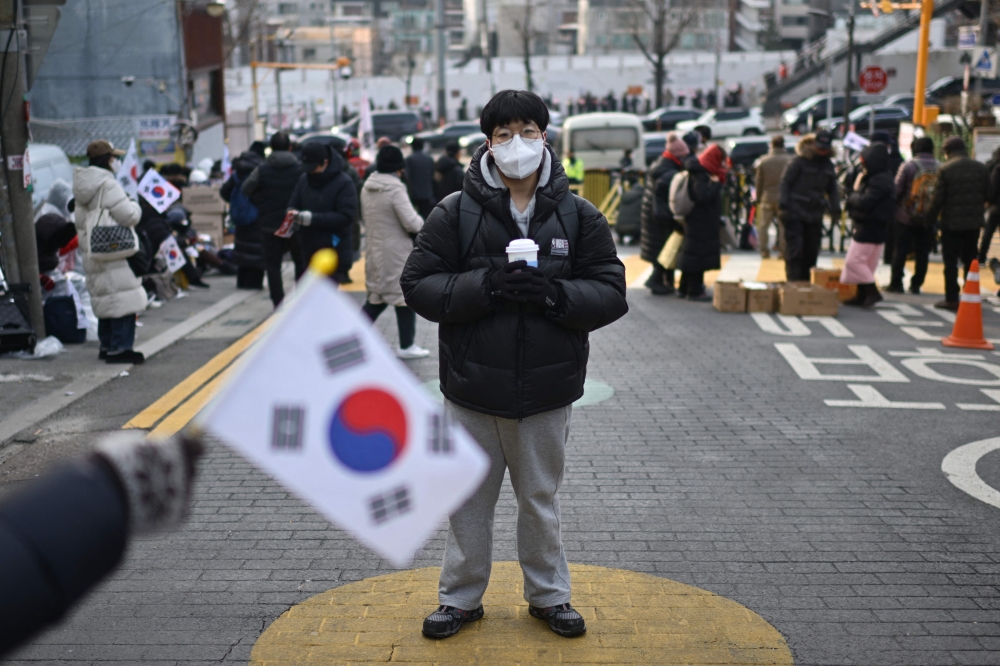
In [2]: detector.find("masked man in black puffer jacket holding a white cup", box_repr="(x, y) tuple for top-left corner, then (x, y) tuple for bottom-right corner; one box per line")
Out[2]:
(400, 90), (628, 638)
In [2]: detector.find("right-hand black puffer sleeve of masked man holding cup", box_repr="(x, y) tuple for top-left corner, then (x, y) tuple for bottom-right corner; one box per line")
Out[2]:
(547, 194), (628, 331)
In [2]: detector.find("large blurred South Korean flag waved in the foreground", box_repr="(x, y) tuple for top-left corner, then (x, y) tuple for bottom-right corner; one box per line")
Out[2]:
(198, 252), (489, 567)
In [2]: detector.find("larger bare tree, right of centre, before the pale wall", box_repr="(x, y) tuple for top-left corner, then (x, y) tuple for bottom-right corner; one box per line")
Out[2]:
(629, 0), (698, 108)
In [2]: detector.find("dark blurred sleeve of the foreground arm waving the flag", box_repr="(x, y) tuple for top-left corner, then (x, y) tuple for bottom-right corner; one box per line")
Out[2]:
(0, 457), (128, 658)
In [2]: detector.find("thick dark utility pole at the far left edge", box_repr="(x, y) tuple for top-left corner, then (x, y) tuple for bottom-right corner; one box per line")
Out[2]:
(0, 6), (45, 339)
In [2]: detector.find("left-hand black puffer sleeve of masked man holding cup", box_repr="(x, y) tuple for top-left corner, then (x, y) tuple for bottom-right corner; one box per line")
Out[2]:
(399, 193), (496, 324)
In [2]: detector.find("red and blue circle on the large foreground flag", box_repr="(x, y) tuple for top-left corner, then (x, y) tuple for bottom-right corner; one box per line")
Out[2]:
(330, 388), (406, 472)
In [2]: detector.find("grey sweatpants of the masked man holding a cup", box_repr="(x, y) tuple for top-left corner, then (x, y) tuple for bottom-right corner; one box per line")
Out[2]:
(438, 400), (573, 610)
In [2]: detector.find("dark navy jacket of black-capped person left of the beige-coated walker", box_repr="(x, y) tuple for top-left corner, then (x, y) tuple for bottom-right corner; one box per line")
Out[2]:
(288, 153), (358, 273)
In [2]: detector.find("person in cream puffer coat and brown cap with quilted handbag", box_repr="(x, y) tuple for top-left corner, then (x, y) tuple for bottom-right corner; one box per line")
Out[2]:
(73, 140), (148, 363)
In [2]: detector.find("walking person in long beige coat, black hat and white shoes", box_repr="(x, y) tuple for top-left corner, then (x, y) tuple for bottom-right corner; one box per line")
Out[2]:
(361, 145), (430, 359)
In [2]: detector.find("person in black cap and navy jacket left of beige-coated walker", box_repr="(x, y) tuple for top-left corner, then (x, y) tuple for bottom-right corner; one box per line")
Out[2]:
(288, 143), (358, 283)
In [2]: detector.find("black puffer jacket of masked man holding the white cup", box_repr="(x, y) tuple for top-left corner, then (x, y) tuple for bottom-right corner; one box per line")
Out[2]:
(400, 146), (628, 419)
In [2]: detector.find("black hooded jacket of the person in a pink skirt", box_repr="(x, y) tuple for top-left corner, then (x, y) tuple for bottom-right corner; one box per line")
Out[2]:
(846, 143), (896, 244)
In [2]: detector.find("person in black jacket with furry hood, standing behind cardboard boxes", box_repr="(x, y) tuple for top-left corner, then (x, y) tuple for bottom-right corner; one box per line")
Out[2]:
(779, 131), (840, 282)
